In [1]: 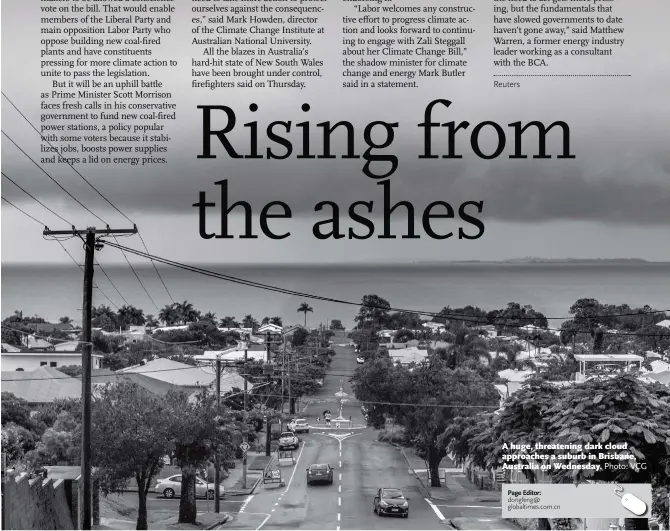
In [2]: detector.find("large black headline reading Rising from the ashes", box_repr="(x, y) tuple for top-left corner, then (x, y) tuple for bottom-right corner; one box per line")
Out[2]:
(193, 99), (575, 240)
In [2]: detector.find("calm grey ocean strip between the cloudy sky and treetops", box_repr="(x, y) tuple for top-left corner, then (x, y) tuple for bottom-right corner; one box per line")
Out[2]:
(1, 263), (670, 326)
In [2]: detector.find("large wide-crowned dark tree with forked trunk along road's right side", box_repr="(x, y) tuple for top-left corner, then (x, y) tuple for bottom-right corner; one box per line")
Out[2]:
(352, 355), (499, 487)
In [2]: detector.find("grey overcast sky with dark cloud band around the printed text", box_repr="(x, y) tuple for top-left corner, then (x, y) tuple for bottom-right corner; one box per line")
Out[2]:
(2, 0), (670, 263)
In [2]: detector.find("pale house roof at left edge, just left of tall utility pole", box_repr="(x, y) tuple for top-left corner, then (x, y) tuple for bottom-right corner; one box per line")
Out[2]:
(2, 367), (81, 406)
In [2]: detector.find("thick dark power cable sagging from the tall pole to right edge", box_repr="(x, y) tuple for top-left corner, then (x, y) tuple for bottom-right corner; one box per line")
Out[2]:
(97, 241), (662, 337)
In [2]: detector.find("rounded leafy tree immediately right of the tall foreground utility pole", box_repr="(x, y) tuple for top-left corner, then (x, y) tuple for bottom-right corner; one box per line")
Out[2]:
(92, 382), (172, 529)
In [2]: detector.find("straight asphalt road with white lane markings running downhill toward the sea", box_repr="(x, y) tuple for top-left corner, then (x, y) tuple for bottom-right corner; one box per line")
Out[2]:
(220, 347), (447, 530)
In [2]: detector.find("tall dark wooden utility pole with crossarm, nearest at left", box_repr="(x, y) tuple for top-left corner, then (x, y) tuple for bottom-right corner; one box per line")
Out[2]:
(42, 226), (137, 530)
